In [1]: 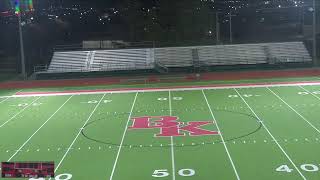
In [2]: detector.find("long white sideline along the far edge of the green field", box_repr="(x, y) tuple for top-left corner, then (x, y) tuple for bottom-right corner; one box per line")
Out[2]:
(10, 82), (320, 97)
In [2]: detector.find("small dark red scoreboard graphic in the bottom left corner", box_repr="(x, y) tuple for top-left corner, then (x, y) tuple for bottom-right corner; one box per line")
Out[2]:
(1, 162), (54, 178)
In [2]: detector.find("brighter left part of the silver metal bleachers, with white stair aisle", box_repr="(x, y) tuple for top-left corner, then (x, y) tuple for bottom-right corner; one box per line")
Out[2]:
(48, 49), (154, 72)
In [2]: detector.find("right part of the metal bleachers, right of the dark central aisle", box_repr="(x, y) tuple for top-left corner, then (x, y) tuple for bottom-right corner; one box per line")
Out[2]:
(197, 42), (312, 65)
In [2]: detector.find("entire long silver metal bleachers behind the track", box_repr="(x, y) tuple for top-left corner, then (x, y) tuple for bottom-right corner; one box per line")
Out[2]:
(48, 42), (312, 72)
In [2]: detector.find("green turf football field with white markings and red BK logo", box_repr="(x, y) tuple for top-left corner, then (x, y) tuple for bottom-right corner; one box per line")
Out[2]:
(0, 79), (320, 180)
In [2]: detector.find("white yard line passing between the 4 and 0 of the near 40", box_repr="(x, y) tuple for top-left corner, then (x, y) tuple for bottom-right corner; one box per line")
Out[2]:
(234, 89), (306, 180)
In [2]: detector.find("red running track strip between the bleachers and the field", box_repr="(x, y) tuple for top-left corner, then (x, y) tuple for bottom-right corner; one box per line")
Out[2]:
(0, 69), (320, 89)
